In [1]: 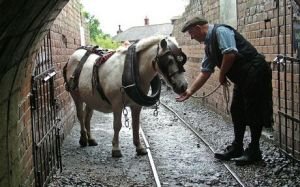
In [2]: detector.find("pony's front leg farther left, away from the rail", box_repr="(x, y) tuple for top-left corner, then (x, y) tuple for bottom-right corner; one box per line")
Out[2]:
(112, 110), (122, 157)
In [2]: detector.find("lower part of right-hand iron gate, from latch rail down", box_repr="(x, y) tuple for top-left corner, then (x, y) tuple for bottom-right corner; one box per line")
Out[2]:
(274, 55), (300, 161)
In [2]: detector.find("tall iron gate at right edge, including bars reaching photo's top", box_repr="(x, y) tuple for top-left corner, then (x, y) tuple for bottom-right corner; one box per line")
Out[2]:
(273, 0), (300, 161)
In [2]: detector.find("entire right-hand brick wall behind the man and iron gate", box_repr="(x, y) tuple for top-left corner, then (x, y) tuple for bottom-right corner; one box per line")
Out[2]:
(173, 0), (300, 158)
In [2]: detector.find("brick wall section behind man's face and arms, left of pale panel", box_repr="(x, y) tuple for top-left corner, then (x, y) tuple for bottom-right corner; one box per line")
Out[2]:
(173, 0), (231, 117)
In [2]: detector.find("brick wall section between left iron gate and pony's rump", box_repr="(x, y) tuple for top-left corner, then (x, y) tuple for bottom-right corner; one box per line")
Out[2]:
(50, 0), (81, 137)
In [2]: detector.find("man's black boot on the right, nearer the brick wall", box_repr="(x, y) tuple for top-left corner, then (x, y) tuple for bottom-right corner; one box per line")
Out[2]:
(235, 146), (262, 166)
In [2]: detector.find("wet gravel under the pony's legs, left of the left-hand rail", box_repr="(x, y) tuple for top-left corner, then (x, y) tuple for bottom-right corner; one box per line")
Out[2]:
(49, 112), (155, 187)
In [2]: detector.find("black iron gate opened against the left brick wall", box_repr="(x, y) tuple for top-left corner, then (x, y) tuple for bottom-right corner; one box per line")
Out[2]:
(30, 32), (62, 186)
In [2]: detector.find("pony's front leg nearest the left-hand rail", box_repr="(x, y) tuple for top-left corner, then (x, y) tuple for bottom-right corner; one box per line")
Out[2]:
(130, 106), (147, 155)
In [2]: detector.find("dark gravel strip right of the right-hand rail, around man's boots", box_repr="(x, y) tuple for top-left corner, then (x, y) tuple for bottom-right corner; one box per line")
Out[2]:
(161, 85), (300, 187)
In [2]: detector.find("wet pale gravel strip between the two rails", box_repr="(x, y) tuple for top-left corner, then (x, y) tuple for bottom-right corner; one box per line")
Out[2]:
(142, 107), (237, 187)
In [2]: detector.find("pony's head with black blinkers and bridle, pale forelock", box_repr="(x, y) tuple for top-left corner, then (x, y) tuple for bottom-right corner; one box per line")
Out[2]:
(152, 37), (188, 94)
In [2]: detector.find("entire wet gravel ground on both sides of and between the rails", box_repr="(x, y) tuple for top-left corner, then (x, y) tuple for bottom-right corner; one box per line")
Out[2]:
(49, 87), (300, 187)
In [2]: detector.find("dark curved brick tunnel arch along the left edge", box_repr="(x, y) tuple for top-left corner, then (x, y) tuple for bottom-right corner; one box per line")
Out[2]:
(0, 0), (68, 186)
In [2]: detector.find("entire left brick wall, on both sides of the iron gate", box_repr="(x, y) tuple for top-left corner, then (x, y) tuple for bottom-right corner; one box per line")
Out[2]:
(16, 0), (89, 186)
